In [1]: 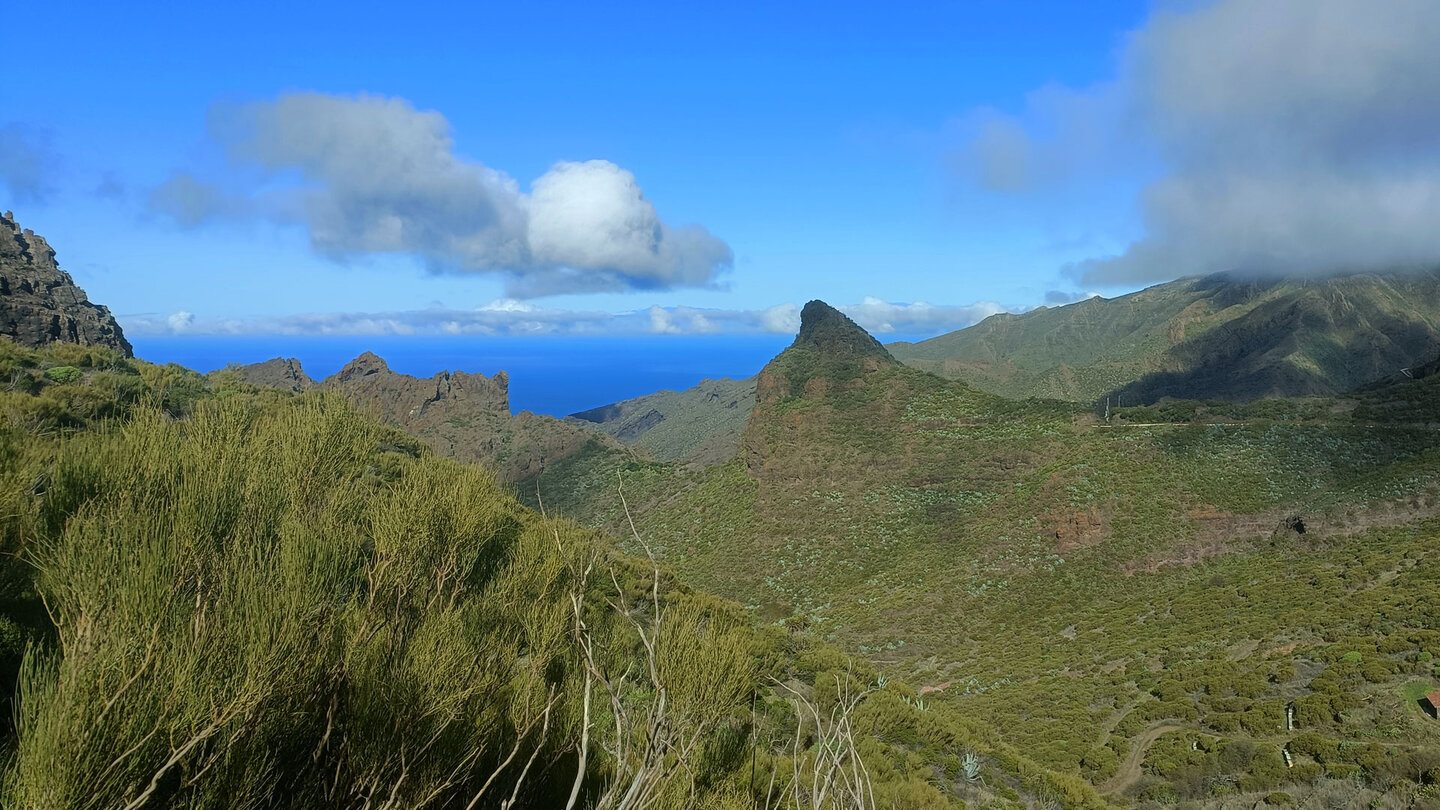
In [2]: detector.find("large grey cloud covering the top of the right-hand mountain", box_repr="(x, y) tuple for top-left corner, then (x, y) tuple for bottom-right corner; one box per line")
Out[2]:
(966, 0), (1440, 284)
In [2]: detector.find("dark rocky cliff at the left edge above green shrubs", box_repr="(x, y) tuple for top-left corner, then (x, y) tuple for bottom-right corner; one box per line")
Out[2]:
(0, 212), (134, 357)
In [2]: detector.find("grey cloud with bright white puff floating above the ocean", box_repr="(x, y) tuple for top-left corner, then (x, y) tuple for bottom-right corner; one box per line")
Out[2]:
(151, 92), (733, 297)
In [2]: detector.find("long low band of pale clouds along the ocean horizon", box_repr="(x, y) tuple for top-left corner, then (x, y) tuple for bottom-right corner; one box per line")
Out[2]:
(120, 297), (1004, 336)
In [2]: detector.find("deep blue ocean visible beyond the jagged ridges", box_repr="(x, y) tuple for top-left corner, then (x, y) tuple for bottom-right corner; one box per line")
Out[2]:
(131, 334), (840, 417)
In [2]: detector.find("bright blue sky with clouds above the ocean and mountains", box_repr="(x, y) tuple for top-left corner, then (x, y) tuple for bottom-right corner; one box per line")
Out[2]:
(0, 0), (1440, 333)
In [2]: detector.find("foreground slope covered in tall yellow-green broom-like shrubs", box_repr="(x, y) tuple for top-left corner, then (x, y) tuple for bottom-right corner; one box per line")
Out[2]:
(0, 342), (1106, 810)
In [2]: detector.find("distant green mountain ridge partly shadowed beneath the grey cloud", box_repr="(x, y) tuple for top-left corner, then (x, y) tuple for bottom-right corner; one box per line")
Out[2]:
(890, 272), (1440, 404)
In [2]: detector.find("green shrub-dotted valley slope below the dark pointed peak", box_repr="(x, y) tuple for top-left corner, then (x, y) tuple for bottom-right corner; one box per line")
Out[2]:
(546, 305), (1440, 807)
